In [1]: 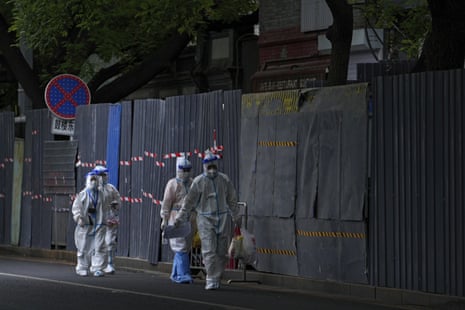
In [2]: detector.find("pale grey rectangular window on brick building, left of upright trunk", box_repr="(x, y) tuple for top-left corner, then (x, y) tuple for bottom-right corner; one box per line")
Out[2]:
(300, 0), (333, 32)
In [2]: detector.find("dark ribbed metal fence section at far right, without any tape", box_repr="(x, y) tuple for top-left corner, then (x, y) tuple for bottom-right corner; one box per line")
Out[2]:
(369, 70), (465, 296)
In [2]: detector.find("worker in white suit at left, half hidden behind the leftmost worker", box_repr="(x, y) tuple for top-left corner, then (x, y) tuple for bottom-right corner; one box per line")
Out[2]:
(92, 166), (121, 274)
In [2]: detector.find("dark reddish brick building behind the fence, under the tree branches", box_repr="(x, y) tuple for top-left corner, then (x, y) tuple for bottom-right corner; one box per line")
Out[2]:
(129, 0), (383, 99)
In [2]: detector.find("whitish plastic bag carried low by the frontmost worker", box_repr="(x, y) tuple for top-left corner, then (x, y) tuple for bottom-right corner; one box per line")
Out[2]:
(228, 228), (257, 265)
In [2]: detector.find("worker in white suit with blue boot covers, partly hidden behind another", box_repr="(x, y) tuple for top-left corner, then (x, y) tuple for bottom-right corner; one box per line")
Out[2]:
(160, 157), (195, 283)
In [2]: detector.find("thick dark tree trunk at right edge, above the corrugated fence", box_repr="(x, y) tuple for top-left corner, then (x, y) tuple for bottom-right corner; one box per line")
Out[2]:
(413, 0), (465, 72)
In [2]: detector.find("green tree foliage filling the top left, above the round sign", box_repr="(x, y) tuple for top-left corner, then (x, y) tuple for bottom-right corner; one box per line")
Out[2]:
(0, 0), (257, 106)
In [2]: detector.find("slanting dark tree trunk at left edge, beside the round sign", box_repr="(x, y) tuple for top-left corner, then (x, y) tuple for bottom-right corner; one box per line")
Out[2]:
(0, 14), (45, 109)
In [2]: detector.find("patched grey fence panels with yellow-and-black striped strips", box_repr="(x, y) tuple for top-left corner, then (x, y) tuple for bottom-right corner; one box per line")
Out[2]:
(240, 83), (368, 283)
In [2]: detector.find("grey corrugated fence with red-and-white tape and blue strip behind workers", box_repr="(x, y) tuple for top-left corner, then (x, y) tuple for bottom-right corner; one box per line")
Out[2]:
(67, 91), (241, 263)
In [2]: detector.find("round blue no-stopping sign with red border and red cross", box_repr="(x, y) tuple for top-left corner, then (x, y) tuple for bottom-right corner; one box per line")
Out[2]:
(45, 74), (90, 119)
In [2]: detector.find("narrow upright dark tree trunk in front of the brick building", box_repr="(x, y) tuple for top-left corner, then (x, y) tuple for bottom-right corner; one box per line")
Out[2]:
(326, 0), (353, 86)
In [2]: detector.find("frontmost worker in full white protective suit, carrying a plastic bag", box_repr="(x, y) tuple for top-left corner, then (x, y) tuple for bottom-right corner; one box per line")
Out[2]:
(175, 151), (241, 290)
